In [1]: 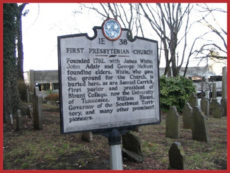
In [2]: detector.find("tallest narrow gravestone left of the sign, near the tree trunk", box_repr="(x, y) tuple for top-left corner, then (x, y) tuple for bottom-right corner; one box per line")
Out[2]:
(33, 91), (42, 130)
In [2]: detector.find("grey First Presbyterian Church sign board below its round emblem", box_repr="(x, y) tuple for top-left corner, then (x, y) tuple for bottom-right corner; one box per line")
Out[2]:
(58, 21), (160, 133)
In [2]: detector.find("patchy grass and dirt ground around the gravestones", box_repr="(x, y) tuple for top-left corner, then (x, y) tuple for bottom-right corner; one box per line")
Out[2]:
(3, 104), (227, 170)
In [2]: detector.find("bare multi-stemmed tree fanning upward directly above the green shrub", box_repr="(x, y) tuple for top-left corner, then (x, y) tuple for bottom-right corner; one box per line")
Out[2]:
(140, 3), (195, 76)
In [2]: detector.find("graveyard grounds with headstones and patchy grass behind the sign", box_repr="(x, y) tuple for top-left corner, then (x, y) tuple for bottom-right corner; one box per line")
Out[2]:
(4, 65), (227, 170)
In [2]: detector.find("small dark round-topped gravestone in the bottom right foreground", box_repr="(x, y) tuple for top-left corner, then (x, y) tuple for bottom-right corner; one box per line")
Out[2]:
(168, 142), (184, 170)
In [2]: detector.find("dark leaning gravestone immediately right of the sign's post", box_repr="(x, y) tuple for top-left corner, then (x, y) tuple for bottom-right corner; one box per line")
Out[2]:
(122, 132), (144, 162)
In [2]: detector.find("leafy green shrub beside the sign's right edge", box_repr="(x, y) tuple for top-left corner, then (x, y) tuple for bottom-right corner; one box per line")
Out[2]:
(160, 76), (195, 112)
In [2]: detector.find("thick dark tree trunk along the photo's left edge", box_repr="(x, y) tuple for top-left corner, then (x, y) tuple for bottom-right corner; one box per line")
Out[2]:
(3, 3), (20, 122)
